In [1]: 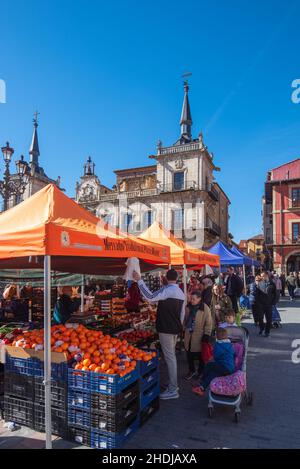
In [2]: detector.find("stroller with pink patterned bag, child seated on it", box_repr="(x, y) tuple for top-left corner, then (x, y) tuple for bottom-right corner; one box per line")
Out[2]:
(208, 326), (253, 423)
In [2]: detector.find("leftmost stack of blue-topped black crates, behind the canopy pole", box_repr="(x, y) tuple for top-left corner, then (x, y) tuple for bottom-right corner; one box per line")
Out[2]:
(4, 355), (67, 437)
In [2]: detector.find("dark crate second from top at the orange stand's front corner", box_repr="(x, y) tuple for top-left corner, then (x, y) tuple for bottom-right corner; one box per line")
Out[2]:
(91, 381), (139, 412)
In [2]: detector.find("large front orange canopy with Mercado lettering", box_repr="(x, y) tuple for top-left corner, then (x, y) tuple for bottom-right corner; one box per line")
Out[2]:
(0, 184), (170, 274)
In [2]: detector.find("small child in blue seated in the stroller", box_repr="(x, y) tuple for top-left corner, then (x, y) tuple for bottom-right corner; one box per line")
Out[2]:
(193, 327), (234, 396)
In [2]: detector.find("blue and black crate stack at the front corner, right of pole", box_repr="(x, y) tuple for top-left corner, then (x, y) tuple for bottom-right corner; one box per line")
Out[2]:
(68, 369), (140, 449)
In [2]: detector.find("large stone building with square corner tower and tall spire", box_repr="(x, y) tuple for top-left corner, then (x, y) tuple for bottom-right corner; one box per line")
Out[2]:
(76, 82), (230, 247)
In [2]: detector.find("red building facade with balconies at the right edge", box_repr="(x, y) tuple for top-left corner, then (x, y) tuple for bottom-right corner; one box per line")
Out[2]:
(263, 158), (300, 273)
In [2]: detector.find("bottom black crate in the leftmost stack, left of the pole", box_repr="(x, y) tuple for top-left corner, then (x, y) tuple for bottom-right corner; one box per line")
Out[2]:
(4, 395), (34, 428)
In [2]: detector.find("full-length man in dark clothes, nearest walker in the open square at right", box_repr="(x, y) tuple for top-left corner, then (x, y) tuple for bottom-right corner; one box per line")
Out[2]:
(257, 272), (277, 337)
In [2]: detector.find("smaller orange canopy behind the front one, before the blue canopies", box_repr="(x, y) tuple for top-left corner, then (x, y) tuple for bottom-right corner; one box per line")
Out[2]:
(139, 221), (220, 267)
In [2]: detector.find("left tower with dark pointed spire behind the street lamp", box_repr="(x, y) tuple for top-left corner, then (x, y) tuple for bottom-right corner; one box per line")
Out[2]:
(1, 113), (60, 208)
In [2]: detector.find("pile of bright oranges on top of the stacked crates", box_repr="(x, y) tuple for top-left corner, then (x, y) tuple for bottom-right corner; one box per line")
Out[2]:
(12, 324), (156, 377)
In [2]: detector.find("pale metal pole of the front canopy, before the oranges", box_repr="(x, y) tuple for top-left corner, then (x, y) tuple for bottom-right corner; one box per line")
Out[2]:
(44, 256), (52, 449)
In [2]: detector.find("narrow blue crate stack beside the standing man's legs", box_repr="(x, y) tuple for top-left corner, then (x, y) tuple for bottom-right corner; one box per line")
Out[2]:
(139, 354), (160, 426)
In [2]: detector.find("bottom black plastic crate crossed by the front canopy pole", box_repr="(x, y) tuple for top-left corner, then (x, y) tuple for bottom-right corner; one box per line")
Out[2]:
(34, 404), (68, 438)
